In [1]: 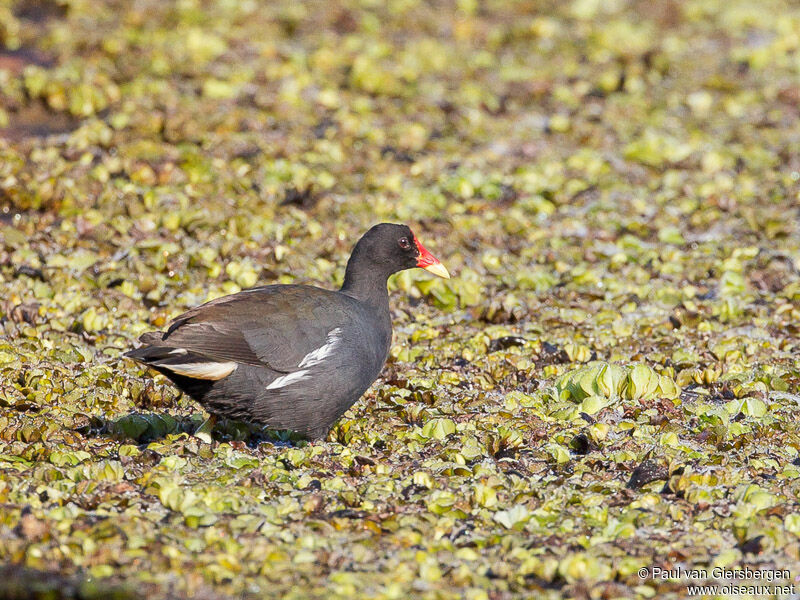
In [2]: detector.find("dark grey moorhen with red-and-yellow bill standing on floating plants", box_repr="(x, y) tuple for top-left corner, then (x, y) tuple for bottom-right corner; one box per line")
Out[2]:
(124, 223), (450, 440)
